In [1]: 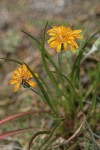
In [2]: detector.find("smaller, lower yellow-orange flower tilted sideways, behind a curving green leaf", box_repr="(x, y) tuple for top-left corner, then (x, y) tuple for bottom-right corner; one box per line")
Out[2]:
(10, 64), (38, 92)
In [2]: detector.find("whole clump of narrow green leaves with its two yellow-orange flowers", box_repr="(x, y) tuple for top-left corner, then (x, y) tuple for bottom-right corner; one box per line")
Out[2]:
(0, 22), (100, 150)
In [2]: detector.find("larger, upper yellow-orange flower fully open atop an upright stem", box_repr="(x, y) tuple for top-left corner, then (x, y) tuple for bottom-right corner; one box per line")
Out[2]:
(47, 26), (83, 53)
